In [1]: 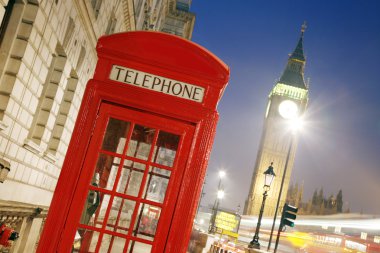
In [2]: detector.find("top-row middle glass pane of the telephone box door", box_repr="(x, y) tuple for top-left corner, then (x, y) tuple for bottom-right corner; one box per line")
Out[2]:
(127, 125), (156, 160)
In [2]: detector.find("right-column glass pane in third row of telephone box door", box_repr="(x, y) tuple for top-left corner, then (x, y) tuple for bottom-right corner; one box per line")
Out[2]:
(133, 203), (161, 241)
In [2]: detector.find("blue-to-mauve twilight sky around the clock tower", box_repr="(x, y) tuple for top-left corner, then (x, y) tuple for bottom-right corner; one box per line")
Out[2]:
(191, 0), (380, 214)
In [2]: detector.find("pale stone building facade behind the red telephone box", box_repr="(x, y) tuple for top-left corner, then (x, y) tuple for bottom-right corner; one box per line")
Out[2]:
(0, 0), (195, 253)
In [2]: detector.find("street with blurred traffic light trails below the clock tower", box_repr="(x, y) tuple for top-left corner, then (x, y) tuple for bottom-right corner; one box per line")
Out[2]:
(195, 213), (380, 253)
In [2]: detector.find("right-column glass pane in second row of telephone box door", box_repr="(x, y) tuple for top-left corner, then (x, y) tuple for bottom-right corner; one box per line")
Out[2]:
(144, 167), (171, 203)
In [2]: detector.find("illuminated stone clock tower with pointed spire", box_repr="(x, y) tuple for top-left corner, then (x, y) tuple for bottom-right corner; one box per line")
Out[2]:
(244, 25), (308, 216)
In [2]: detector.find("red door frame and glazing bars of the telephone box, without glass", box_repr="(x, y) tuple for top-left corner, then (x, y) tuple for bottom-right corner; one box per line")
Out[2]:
(59, 104), (194, 252)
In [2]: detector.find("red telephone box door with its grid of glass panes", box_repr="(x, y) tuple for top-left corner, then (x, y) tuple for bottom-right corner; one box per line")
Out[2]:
(59, 103), (194, 253)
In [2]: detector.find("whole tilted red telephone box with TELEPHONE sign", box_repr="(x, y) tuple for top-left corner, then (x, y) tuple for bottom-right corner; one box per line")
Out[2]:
(37, 32), (229, 253)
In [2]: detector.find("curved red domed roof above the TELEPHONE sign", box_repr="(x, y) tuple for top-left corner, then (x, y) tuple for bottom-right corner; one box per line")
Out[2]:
(97, 31), (230, 86)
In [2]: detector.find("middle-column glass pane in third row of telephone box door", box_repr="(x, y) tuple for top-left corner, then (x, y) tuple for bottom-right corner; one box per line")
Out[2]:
(107, 197), (136, 234)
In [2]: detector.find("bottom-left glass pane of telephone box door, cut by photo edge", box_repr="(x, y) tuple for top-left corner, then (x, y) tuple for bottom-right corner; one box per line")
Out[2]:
(71, 229), (99, 252)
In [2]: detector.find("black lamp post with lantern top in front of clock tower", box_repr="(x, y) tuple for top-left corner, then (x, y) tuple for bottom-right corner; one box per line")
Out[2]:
(248, 162), (276, 249)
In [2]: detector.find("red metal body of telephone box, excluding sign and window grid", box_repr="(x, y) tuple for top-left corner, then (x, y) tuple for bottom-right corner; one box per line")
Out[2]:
(37, 32), (229, 253)
